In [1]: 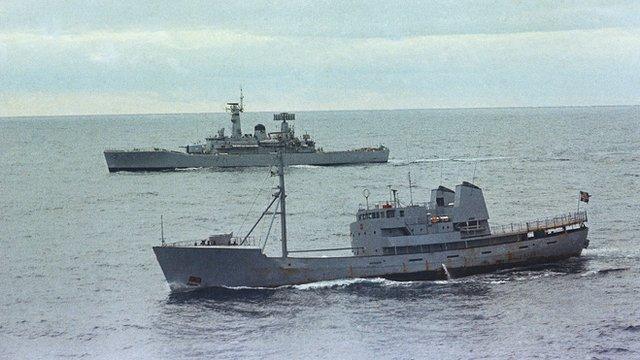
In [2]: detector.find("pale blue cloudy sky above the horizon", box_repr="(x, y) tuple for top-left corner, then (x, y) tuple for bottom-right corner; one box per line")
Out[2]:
(0, 0), (640, 116)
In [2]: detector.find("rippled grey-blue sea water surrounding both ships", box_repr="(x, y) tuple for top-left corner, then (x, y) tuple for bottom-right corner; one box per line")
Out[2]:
(0, 107), (640, 359)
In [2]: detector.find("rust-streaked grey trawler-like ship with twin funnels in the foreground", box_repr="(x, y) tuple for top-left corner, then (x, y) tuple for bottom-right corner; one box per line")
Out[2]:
(153, 148), (589, 291)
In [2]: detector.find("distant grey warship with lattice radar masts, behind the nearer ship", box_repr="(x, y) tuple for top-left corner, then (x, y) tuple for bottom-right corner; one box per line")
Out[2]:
(104, 95), (389, 172)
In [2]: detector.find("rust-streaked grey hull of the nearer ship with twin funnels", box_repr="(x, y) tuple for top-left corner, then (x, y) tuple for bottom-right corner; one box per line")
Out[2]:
(153, 227), (588, 290)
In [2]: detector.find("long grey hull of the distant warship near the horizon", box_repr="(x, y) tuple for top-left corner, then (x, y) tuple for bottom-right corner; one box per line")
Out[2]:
(104, 148), (389, 172)
